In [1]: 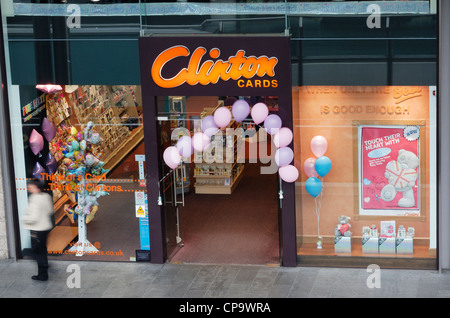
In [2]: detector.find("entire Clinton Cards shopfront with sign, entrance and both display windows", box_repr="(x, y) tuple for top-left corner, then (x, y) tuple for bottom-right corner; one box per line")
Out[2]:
(9, 35), (438, 269)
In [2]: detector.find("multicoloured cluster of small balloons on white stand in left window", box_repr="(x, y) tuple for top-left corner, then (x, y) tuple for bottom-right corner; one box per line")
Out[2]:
(61, 122), (109, 223)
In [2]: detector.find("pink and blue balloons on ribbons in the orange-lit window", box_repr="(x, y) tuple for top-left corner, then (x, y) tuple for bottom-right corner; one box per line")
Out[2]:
(303, 136), (331, 249)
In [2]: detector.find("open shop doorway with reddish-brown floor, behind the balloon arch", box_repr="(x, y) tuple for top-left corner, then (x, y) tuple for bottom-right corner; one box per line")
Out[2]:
(157, 96), (280, 265)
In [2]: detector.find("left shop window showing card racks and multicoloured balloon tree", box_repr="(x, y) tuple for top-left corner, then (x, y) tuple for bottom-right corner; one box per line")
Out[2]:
(17, 85), (142, 260)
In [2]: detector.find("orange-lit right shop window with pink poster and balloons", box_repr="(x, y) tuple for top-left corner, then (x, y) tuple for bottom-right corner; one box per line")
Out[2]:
(294, 86), (437, 268)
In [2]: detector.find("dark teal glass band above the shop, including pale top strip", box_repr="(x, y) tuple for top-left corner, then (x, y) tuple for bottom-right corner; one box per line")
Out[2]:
(1, 0), (437, 85)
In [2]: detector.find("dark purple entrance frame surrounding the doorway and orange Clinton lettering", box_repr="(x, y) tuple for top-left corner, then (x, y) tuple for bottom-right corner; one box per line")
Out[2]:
(139, 36), (297, 266)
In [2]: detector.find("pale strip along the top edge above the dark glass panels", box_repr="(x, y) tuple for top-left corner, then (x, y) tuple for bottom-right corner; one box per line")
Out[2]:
(9, 0), (435, 16)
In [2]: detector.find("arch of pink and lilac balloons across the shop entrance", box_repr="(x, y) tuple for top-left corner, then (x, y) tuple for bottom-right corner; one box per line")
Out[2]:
(163, 99), (298, 183)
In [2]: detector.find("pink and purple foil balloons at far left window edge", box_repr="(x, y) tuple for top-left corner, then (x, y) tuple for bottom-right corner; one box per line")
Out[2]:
(29, 118), (57, 180)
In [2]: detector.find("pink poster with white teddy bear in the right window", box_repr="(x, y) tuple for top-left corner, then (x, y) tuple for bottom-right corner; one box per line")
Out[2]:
(360, 126), (420, 210)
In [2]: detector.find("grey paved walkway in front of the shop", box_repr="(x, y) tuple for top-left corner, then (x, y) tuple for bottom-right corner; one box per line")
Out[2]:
(0, 260), (450, 298)
